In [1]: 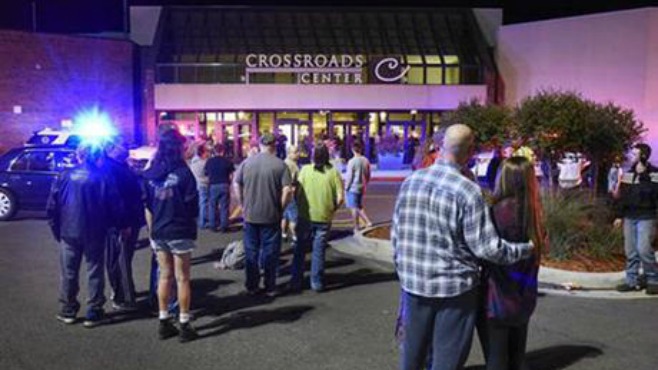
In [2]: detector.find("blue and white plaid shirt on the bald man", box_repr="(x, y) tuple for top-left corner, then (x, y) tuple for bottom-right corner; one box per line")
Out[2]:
(391, 159), (531, 297)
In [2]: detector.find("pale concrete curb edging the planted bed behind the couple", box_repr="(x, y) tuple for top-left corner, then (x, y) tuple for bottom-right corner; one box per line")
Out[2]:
(331, 224), (658, 299)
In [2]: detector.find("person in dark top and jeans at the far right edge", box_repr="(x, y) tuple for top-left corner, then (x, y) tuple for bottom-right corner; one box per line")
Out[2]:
(614, 143), (658, 295)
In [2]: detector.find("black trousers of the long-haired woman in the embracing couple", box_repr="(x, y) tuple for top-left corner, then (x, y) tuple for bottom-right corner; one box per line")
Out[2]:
(478, 320), (528, 370)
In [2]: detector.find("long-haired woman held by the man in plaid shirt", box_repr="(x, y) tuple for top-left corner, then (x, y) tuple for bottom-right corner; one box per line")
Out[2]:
(478, 157), (545, 370)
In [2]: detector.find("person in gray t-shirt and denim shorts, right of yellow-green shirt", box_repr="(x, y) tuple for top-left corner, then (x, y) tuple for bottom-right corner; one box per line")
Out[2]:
(345, 141), (372, 233)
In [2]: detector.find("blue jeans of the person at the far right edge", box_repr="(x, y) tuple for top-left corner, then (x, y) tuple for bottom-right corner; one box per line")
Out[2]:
(624, 218), (658, 286)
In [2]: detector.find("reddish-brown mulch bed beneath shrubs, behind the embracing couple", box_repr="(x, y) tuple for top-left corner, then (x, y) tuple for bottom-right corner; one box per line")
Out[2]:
(365, 226), (626, 272)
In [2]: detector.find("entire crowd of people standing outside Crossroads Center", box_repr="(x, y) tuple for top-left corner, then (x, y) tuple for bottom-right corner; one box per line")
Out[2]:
(48, 120), (658, 370)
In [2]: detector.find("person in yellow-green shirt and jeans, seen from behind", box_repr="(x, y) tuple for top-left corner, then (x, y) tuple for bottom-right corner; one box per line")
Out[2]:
(290, 142), (343, 292)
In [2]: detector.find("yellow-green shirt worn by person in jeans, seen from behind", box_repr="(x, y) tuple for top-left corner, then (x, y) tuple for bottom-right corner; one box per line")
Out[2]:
(297, 164), (343, 223)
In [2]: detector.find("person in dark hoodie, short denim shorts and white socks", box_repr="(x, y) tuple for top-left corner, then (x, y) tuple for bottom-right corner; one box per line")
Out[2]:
(143, 130), (199, 342)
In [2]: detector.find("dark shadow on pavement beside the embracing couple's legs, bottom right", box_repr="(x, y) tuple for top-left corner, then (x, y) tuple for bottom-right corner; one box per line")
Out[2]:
(465, 345), (603, 370)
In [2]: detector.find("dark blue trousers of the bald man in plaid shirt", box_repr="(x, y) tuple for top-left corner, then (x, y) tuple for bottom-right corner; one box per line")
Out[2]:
(400, 289), (478, 370)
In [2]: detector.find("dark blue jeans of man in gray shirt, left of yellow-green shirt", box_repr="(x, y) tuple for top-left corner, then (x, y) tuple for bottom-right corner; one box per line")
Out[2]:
(244, 222), (281, 292)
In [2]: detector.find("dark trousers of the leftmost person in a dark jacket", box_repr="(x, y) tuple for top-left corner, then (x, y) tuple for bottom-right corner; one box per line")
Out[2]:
(59, 237), (105, 315)
